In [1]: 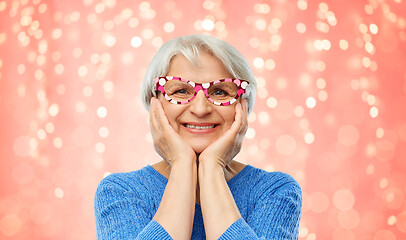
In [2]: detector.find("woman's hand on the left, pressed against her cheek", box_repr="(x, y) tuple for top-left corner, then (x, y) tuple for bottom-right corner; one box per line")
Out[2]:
(150, 97), (196, 168)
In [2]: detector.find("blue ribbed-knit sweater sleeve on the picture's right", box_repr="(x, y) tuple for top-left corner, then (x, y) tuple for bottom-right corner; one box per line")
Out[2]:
(219, 174), (302, 240)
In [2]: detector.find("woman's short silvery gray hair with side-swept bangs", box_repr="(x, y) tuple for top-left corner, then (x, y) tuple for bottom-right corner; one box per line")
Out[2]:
(141, 34), (257, 113)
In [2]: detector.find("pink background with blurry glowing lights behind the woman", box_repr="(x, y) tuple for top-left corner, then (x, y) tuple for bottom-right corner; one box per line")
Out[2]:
(0, 0), (406, 240)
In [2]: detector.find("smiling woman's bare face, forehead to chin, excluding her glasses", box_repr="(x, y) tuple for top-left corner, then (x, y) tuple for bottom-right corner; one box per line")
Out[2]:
(159, 51), (235, 153)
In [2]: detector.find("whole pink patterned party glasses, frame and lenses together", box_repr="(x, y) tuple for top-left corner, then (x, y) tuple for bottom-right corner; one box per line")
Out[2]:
(154, 76), (248, 106)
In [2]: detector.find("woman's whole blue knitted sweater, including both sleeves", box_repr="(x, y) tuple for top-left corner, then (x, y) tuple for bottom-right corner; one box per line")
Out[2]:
(95, 165), (302, 240)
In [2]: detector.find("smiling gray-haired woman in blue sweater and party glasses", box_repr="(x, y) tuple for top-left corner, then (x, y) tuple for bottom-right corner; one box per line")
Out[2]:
(95, 35), (302, 239)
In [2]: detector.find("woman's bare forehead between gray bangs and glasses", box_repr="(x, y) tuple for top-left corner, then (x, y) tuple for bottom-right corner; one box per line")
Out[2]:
(167, 51), (232, 83)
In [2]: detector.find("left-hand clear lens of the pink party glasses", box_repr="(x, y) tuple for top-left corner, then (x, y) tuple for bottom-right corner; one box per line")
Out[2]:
(164, 80), (195, 102)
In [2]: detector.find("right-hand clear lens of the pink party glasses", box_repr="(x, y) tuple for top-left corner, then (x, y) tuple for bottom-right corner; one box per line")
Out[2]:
(207, 82), (238, 103)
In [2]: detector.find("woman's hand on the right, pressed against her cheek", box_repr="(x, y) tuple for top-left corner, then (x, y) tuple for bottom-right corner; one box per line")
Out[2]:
(199, 99), (248, 169)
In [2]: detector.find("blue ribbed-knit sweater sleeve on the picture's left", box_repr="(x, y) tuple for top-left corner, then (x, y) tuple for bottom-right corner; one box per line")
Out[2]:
(94, 175), (172, 240)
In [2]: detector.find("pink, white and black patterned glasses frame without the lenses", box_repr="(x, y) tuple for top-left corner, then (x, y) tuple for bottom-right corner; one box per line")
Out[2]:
(154, 76), (249, 106)
